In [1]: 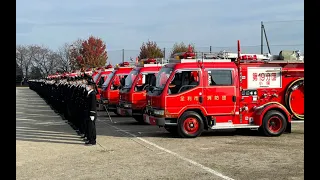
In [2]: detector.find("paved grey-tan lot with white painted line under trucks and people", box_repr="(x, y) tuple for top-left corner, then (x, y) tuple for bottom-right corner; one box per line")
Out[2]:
(16, 87), (304, 180)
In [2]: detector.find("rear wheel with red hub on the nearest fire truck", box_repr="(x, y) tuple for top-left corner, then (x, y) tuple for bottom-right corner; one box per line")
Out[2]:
(260, 110), (287, 136)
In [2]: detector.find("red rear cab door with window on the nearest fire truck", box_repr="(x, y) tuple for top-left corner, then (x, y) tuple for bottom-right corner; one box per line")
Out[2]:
(204, 68), (236, 123)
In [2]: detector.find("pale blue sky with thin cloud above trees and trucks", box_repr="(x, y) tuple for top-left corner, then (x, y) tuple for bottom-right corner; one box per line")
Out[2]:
(16, 0), (304, 63)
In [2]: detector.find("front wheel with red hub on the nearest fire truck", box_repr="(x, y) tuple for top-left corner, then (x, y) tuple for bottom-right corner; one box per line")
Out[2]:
(177, 111), (204, 138)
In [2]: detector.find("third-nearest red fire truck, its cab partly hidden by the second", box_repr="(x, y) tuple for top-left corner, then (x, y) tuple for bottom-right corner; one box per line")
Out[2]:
(101, 62), (134, 113)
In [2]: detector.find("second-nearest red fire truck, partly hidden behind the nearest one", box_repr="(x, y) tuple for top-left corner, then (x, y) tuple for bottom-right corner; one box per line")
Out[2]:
(117, 58), (165, 122)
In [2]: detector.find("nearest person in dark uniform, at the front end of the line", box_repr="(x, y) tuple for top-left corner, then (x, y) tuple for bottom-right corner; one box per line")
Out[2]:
(85, 79), (97, 145)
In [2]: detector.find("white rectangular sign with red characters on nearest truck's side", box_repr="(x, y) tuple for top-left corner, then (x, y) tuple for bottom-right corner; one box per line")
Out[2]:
(247, 67), (282, 89)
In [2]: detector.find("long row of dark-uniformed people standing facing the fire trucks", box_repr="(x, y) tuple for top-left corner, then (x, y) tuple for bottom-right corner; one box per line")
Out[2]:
(28, 74), (97, 145)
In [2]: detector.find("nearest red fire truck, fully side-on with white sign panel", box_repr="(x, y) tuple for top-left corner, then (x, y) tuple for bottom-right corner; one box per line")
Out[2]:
(144, 42), (304, 137)
